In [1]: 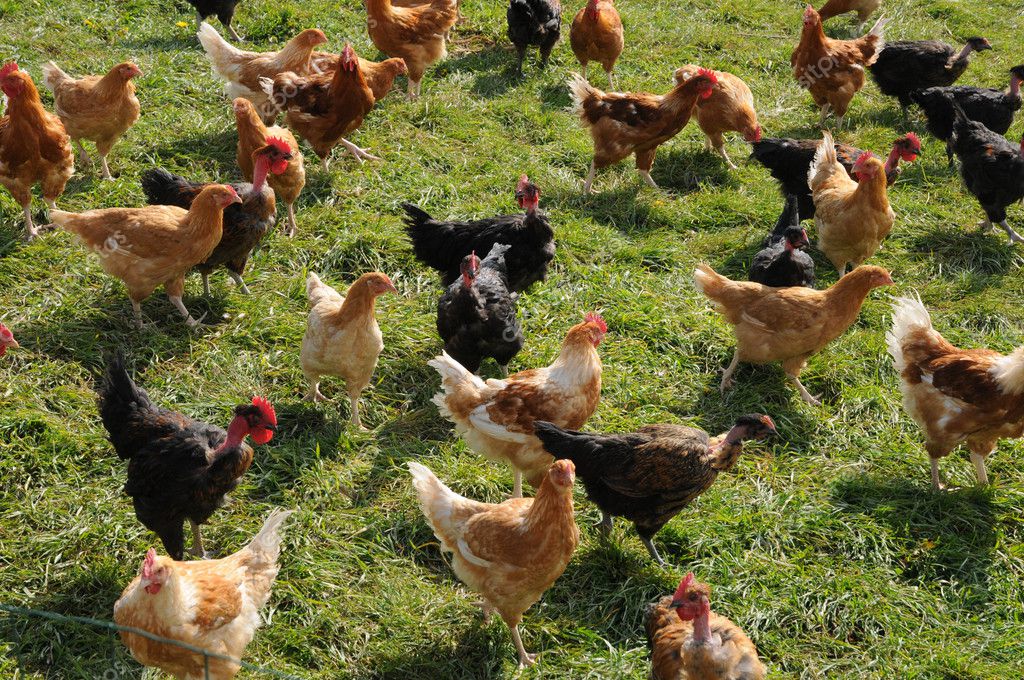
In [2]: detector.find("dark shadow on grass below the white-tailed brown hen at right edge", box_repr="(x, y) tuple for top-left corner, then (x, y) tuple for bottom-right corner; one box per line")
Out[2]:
(831, 474), (996, 603)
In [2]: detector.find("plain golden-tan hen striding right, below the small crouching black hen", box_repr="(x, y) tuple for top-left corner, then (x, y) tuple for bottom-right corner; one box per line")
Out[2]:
(693, 264), (893, 406)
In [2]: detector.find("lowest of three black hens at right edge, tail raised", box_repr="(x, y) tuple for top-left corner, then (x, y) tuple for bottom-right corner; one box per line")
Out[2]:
(950, 104), (1024, 244)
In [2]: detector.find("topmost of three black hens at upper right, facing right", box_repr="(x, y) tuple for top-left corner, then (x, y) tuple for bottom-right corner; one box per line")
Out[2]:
(870, 38), (992, 116)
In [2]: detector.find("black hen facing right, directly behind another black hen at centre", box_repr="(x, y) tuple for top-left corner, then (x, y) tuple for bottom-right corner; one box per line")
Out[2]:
(401, 175), (555, 293)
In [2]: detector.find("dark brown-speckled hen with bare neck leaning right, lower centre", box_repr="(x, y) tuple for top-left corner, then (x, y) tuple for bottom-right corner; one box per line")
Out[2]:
(534, 415), (775, 566)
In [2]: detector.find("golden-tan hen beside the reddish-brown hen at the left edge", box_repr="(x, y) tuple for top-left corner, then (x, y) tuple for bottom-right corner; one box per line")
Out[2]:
(43, 61), (142, 179)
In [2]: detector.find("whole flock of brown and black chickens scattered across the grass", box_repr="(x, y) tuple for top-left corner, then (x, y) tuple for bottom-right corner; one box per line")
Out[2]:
(0, 0), (1024, 680)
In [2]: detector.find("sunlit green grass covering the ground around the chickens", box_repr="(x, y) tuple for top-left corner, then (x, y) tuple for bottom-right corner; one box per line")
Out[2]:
(0, 0), (1024, 680)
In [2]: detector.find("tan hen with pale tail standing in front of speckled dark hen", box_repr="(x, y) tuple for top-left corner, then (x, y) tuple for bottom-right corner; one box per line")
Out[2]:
(408, 461), (580, 668)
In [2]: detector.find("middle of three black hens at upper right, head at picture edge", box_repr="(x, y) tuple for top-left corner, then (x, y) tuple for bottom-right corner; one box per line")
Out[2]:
(910, 65), (1024, 165)
